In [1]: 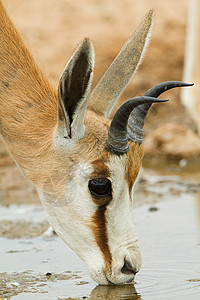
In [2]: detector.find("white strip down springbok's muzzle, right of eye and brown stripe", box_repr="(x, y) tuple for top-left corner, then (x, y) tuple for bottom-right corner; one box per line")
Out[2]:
(105, 155), (141, 281)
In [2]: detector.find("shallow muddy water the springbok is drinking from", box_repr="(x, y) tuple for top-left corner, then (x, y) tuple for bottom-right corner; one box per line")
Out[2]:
(0, 165), (200, 300)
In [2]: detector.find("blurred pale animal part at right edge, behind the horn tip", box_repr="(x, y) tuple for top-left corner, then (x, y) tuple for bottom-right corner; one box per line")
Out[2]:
(181, 0), (200, 135)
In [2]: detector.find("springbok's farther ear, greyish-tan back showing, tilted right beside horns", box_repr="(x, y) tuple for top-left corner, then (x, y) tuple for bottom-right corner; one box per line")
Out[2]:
(88, 10), (153, 117)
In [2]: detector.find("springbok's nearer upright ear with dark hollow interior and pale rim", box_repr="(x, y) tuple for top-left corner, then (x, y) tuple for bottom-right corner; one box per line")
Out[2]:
(58, 39), (94, 140)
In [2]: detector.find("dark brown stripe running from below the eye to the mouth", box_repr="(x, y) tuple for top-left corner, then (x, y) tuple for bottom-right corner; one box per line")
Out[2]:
(91, 206), (112, 272)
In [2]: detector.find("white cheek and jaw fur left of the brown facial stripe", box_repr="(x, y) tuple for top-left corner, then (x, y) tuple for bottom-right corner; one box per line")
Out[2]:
(38, 164), (108, 284)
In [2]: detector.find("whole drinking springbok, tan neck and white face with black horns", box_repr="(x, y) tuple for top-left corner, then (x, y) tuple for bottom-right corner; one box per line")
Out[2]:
(0, 1), (192, 284)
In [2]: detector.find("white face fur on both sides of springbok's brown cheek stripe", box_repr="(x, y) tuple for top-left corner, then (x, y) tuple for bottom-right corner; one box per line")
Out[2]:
(39, 155), (141, 284)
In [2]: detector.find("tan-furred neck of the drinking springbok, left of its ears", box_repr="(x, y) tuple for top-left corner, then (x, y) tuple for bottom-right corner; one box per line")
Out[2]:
(0, 2), (57, 176)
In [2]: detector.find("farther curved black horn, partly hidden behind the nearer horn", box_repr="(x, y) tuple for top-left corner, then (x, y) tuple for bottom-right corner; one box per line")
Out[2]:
(127, 81), (193, 144)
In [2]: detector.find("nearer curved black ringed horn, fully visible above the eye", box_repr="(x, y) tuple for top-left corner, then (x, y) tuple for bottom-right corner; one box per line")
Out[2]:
(107, 95), (168, 155)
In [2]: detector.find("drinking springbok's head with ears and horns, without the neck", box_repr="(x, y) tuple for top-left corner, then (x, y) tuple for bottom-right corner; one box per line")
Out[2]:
(36, 11), (191, 284)
